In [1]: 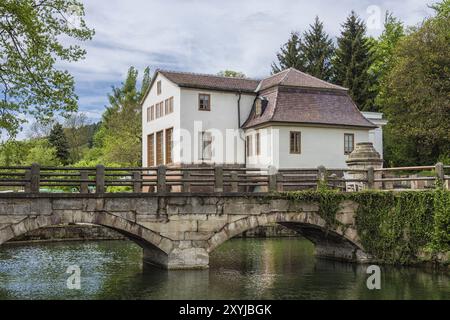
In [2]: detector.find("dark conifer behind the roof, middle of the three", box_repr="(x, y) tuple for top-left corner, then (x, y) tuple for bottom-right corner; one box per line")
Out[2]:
(302, 16), (334, 81)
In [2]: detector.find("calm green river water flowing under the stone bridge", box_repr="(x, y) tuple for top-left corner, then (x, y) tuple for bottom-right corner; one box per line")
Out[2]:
(0, 239), (450, 299)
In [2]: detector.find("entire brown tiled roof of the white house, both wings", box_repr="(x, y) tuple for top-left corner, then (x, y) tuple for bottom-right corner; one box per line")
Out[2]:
(148, 68), (376, 128)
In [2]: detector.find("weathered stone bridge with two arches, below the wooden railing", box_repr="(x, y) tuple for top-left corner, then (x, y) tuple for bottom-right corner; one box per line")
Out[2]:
(0, 193), (370, 269)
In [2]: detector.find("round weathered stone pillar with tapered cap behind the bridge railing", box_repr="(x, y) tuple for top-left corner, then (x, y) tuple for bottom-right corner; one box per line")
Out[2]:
(346, 142), (383, 189)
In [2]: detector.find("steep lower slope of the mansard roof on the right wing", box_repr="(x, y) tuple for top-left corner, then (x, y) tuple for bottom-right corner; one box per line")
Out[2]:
(243, 87), (375, 128)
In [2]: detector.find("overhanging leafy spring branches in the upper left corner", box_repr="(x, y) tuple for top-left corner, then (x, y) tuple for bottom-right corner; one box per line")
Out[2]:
(0, 0), (93, 135)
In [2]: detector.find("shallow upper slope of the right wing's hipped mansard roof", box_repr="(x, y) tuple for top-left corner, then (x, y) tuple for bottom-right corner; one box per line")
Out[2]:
(257, 68), (347, 91)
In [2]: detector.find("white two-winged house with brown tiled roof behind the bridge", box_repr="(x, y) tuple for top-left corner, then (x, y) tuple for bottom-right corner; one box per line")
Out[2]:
(142, 69), (385, 168)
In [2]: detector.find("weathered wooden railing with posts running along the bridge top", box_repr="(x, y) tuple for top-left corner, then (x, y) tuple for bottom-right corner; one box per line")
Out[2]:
(0, 163), (450, 194)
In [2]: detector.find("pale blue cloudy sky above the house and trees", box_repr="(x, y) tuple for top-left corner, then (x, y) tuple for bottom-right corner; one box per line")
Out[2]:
(20, 0), (435, 136)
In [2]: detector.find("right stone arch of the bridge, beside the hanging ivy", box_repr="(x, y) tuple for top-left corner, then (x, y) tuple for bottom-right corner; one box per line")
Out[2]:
(207, 212), (370, 262)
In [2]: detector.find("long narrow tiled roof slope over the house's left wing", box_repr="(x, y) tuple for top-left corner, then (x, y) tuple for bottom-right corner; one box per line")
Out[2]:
(158, 70), (260, 93)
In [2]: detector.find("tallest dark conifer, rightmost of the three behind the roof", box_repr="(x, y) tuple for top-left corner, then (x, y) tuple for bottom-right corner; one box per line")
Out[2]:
(333, 12), (375, 111)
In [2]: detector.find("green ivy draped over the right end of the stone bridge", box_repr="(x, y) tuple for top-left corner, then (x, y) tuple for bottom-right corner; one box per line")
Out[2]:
(282, 188), (450, 264)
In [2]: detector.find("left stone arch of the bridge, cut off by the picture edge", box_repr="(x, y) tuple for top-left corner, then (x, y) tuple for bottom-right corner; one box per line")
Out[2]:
(0, 211), (172, 256)
